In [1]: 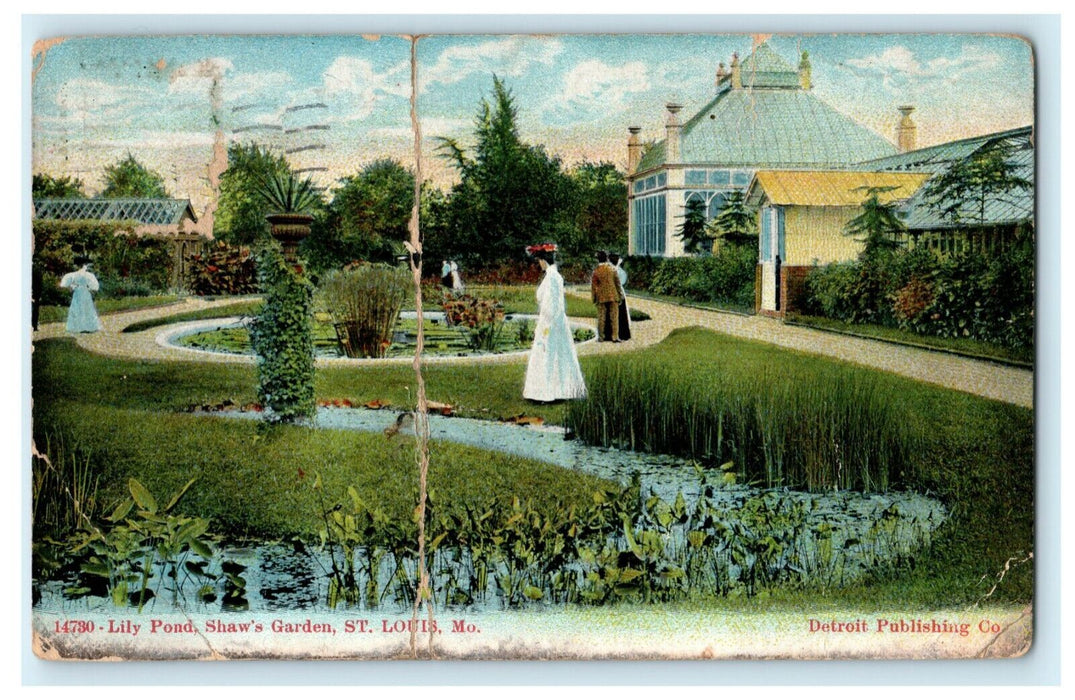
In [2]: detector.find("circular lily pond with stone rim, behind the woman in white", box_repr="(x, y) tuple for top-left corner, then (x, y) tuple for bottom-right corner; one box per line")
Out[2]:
(166, 312), (596, 358)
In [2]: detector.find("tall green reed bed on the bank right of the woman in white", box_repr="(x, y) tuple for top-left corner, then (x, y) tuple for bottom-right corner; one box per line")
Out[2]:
(567, 356), (917, 491)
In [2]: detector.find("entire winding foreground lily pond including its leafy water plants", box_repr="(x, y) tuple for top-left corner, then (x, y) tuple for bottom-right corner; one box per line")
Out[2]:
(33, 408), (946, 613)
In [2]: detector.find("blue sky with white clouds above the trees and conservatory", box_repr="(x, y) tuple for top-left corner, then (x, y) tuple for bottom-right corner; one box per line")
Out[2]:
(32, 34), (1033, 212)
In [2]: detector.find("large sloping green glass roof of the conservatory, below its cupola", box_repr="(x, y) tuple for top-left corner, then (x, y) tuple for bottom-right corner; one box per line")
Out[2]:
(637, 87), (895, 172)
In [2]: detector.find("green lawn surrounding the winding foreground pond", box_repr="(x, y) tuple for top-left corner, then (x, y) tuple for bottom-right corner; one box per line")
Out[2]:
(33, 329), (1034, 606)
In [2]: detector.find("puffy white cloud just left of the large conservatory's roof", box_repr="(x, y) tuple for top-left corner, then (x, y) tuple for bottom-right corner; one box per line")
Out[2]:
(545, 58), (651, 115)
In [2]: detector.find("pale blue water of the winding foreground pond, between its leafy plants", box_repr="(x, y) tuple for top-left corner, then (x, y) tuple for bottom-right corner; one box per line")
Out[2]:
(34, 408), (947, 613)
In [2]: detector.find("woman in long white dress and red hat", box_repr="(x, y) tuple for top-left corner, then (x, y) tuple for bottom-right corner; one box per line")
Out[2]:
(522, 243), (586, 401)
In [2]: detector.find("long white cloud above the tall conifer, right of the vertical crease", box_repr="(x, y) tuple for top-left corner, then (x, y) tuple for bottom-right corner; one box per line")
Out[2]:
(418, 37), (563, 90)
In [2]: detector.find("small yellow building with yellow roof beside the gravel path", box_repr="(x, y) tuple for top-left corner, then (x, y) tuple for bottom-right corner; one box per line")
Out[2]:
(746, 170), (930, 316)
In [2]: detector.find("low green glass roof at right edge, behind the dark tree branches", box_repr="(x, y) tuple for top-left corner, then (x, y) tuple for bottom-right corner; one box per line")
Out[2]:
(856, 126), (1034, 231)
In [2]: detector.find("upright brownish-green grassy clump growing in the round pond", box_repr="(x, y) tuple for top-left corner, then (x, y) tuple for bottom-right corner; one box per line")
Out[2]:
(320, 263), (411, 357)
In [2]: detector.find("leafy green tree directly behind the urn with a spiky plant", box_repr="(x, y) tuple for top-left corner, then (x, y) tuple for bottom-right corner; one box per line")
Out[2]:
(213, 143), (291, 245)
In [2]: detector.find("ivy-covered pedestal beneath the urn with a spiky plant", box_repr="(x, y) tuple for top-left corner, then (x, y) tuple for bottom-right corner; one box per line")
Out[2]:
(250, 243), (315, 422)
